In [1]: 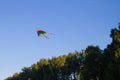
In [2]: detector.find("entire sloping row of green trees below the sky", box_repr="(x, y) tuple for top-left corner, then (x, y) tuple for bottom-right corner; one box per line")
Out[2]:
(5, 25), (120, 80)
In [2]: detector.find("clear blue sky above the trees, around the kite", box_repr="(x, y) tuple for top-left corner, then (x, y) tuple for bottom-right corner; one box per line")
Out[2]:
(0, 0), (120, 80)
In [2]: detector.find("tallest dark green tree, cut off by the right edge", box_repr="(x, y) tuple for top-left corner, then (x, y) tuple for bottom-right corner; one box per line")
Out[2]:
(103, 23), (120, 80)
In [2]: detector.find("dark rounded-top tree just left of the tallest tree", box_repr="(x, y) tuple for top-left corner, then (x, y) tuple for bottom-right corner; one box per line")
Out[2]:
(82, 46), (102, 80)
